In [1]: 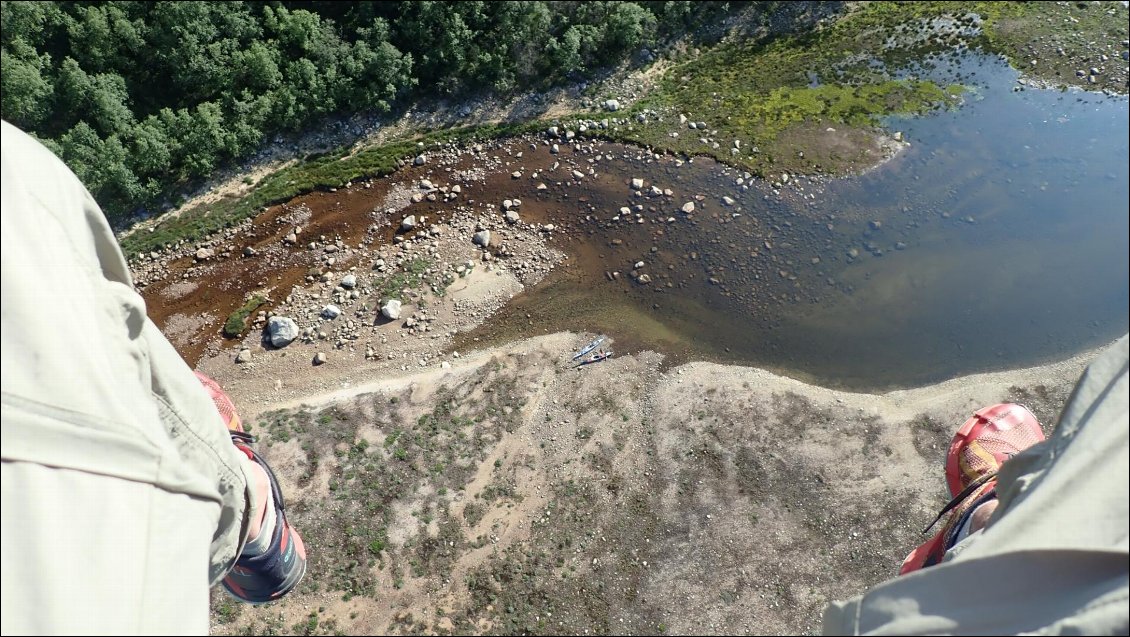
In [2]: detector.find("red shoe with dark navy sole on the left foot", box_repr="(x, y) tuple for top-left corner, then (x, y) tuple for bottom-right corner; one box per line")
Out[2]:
(195, 372), (306, 604)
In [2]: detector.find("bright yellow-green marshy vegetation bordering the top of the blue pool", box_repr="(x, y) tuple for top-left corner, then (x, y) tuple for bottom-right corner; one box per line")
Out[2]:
(603, 2), (1127, 175)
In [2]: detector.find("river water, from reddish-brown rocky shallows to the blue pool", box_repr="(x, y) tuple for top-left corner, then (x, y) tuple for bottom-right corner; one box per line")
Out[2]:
(138, 53), (1130, 389)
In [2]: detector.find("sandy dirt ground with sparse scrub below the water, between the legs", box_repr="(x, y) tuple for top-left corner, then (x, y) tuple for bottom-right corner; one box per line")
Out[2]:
(205, 325), (1096, 635)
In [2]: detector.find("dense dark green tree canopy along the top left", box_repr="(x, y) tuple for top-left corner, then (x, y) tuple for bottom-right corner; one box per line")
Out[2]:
(0, 0), (729, 218)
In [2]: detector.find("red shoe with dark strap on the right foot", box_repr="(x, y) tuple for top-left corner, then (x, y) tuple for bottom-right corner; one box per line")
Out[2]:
(898, 403), (1044, 575)
